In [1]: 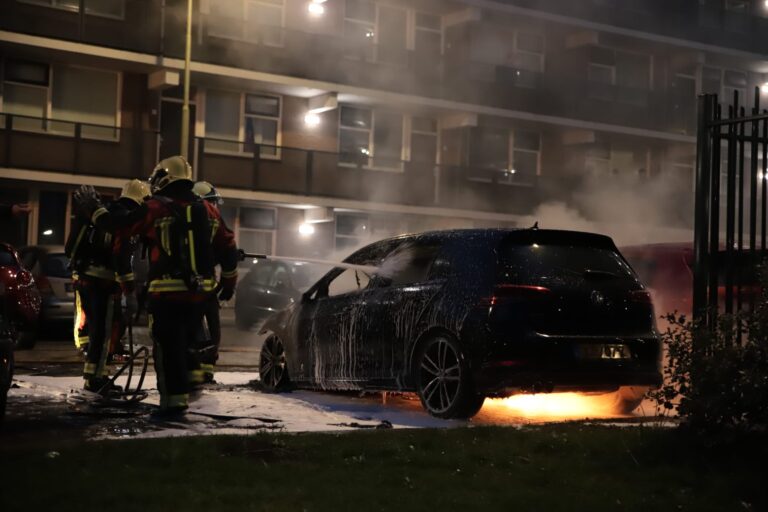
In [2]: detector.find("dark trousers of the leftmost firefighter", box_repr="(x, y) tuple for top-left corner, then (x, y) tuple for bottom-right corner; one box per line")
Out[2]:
(78, 278), (120, 380)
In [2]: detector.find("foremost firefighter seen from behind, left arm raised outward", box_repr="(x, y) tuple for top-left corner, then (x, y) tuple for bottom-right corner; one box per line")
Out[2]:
(78, 156), (238, 416)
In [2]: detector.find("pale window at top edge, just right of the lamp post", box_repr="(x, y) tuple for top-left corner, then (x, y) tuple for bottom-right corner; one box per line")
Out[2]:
(207, 0), (285, 46)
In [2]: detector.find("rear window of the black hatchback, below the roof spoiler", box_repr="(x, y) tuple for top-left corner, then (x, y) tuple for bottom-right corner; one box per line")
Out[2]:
(498, 240), (635, 284)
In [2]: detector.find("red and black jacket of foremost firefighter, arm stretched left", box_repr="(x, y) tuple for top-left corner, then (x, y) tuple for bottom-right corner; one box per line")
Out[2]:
(96, 182), (238, 302)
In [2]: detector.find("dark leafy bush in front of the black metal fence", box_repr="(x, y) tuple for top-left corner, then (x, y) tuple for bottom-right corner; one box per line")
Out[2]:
(651, 297), (768, 430)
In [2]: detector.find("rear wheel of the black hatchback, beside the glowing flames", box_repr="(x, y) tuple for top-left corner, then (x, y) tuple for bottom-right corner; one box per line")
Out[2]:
(412, 335), (485, 419)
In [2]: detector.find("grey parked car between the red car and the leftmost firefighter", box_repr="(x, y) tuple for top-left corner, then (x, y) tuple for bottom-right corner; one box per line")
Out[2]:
(19, 245), (75, 325)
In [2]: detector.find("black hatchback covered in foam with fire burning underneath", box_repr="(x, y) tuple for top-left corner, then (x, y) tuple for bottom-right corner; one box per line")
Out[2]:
(260, 229), (661, 418)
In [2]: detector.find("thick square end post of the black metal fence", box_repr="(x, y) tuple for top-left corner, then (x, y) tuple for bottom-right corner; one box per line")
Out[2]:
(693, 94), (720, 326)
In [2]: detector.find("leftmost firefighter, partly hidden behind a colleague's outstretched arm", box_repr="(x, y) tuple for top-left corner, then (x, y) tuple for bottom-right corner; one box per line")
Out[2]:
(65, 180), (149, 394)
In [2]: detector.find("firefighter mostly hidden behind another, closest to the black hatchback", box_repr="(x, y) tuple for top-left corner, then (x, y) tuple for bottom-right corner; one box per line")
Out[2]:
(192, 181), (232, 383)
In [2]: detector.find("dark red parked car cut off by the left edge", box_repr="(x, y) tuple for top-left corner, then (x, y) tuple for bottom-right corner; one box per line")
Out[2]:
(0, 243), (41, 348)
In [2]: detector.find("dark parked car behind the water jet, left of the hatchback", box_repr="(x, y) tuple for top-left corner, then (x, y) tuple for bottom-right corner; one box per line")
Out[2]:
(235, 259), (322, 330)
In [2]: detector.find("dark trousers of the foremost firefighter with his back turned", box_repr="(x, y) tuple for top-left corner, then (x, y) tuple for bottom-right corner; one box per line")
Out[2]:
(149, 297), (203, 409)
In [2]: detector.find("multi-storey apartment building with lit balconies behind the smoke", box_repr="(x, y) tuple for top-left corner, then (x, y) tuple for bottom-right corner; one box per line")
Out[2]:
(0, 0), (768, 256)
